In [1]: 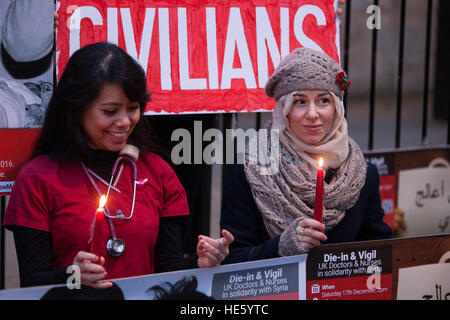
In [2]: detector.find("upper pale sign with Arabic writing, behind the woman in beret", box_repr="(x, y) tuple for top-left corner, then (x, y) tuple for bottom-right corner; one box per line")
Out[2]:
(398, 168), (450, 237)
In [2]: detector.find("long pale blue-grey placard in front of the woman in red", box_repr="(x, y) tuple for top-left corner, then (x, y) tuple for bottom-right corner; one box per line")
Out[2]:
(0, 255), (306, 300)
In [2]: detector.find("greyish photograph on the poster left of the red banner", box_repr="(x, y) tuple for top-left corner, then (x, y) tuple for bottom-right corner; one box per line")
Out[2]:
(0, 0), (56, 129)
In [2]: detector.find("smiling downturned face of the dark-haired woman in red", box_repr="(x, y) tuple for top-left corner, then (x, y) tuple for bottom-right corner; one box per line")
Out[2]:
(81, 84), (140, 152)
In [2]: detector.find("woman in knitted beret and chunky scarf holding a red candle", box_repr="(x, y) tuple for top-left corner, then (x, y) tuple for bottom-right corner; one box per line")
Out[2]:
(221, 48), (392, 263)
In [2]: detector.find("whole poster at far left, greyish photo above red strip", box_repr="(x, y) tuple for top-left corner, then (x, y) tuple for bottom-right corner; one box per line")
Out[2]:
(0, 0), (56, 192)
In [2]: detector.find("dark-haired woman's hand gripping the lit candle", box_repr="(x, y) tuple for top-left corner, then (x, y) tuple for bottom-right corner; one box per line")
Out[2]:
(73, 251), (112, 289)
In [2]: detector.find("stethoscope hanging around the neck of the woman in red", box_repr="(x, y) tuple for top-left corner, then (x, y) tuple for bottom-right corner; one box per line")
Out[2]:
(81, 155), (137, 257)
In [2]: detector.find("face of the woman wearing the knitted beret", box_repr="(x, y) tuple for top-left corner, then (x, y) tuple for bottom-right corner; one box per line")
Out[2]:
(287, 90), (336, 145)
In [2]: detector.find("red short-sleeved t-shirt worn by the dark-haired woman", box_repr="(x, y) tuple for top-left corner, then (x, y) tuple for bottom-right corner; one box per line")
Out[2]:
(4, 152), (189, 279)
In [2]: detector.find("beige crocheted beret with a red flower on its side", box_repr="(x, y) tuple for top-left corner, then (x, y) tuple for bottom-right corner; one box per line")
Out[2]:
(265, 48), (350, 100)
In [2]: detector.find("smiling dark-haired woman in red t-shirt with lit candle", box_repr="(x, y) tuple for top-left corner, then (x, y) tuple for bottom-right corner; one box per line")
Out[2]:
(4, 43), (233, 288)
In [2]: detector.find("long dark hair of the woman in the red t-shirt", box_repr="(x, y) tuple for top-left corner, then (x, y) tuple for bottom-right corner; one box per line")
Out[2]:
(32, 42), (166, 160)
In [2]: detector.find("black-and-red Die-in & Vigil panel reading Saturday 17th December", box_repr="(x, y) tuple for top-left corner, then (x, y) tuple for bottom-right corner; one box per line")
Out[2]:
(306, 246), (392, 300)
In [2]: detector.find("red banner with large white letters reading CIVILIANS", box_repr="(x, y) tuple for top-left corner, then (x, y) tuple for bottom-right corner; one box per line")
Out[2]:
(56, 0), (339, 114)
